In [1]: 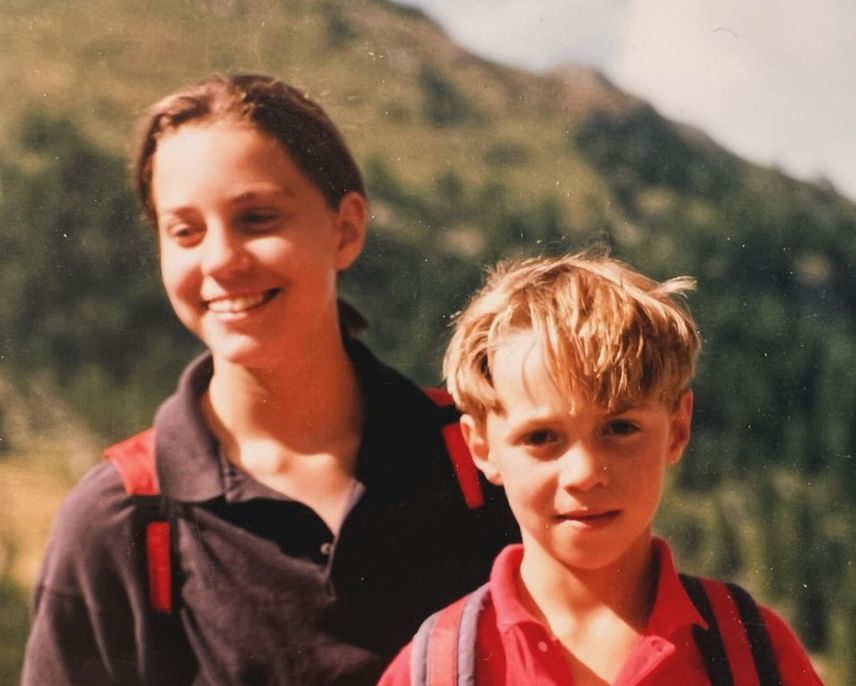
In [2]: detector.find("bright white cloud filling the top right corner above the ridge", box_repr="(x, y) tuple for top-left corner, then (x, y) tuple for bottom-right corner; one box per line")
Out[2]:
(608, 0), (856, 197)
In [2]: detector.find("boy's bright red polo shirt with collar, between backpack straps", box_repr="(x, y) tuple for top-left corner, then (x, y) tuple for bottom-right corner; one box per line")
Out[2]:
(379, 539), (822, 686)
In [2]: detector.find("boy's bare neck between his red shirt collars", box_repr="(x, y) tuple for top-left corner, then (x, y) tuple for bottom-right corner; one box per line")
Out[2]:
(518, 533), (657, 647)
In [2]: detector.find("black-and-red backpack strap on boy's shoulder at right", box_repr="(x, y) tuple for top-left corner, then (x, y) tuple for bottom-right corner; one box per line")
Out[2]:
(680, 574), (781, 686)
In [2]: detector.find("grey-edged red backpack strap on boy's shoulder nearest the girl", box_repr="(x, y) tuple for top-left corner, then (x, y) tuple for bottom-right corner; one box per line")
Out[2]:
(410, 584), (490, 686)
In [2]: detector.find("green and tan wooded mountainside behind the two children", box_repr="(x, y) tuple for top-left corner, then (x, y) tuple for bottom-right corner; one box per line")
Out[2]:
(0, 0), (856, 686)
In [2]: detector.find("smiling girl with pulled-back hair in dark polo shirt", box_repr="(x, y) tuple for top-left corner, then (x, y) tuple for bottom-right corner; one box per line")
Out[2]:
(24, 76), (513, 686)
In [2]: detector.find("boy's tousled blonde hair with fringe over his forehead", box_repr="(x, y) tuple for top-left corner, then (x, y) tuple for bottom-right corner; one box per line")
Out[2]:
(443, 254), (701, 422)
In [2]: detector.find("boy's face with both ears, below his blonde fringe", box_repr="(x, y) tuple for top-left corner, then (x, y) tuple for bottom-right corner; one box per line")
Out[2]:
(463, 332), (692, 572)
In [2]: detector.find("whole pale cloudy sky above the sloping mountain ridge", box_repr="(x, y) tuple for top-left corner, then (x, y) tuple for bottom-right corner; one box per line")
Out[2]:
(399, 0), (856, 199)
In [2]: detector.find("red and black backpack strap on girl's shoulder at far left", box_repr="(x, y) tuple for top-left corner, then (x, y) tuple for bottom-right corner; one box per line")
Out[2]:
(104, 429), (173, 614)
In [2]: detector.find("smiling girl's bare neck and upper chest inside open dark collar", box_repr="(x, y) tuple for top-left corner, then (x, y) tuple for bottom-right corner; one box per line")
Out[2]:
(202, 336), (364, 535)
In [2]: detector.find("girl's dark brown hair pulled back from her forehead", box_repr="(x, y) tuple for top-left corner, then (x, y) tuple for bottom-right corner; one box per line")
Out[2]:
(133, 74), (365, 222)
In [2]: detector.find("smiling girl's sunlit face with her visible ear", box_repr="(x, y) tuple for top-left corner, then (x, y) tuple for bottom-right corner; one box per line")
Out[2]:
(152, 123), (366, 367)
